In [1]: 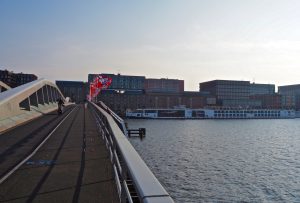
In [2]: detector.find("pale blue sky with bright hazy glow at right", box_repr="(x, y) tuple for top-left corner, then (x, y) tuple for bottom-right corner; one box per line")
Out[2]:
(0, 0), (300, 91)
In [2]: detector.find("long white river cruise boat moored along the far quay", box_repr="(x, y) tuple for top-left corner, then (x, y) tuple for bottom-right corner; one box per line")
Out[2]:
(126, 109), (296, 119)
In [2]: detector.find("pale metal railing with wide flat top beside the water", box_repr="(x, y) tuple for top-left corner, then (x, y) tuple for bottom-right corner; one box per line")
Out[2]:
(90, 103), (174, 203)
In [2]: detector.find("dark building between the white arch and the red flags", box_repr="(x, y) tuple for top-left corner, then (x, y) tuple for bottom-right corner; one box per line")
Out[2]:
(55, 81), (88, 103)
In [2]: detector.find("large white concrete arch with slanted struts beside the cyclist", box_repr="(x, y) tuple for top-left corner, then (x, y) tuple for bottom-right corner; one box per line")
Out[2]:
(0, 79), (65, 133)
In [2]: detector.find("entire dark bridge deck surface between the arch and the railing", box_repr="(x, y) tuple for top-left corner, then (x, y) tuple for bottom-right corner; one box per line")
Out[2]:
(0, 105), (118, 202)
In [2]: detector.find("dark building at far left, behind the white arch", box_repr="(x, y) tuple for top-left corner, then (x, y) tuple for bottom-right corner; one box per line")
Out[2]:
(0, 70), (37, 88)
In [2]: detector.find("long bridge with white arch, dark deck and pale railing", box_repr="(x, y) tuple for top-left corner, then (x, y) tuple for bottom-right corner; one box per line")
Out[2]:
(0, 79), (173, 203)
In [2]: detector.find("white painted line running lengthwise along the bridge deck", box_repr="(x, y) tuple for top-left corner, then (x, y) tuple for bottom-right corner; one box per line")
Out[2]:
(0, 106), (78, 185)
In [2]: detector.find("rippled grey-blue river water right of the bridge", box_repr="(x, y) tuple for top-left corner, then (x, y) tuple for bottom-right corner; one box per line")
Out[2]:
(127, 119), (300, 203)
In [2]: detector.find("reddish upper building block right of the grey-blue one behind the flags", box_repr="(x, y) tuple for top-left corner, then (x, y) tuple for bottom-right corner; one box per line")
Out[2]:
(145, 78), (184, 93)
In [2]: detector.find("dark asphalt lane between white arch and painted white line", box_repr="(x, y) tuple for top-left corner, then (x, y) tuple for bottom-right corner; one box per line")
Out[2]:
(0, 105), (75, 177)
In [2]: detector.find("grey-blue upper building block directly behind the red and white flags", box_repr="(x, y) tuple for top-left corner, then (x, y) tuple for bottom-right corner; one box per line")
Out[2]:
(88, 73), (145, 90)
